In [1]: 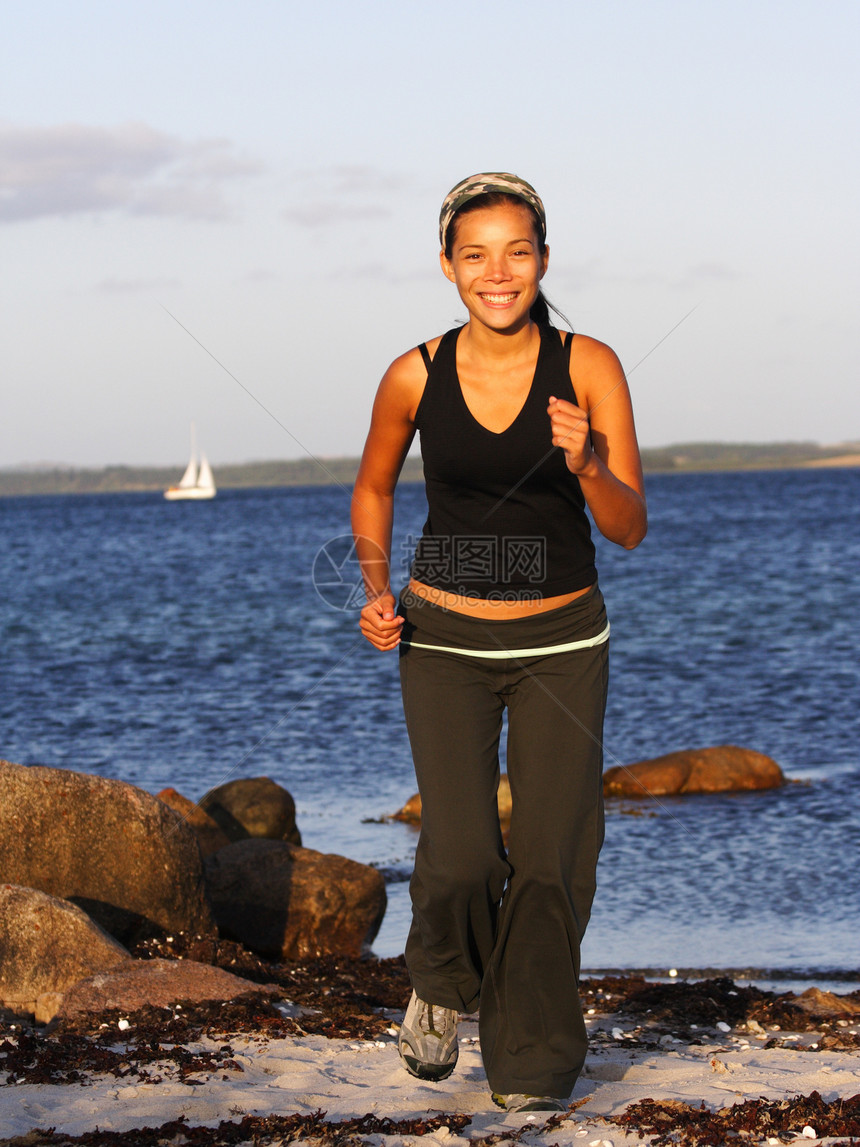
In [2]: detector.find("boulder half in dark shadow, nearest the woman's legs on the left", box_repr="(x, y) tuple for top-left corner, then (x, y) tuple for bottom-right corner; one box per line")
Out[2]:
(206, 840), (386, 960)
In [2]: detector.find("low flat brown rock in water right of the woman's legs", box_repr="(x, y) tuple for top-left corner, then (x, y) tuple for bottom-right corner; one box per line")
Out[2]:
(603, 744), (785, 797)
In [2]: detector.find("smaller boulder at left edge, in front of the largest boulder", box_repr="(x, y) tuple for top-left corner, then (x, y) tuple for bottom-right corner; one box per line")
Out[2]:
(0, 884), (130, 1019)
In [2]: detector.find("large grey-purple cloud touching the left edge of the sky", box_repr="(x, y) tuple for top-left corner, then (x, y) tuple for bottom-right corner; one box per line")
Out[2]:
(0, 123), (260, 223)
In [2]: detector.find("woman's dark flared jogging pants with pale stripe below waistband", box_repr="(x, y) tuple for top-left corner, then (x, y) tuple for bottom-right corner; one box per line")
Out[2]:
(400, 586), (609, 1099)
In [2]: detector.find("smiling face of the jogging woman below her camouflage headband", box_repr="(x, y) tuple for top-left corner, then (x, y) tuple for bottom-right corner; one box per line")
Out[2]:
(440, 203), (549, 330)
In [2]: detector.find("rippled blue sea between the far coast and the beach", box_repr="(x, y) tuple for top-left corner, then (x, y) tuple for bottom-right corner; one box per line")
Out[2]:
(0, 469), (860, 984)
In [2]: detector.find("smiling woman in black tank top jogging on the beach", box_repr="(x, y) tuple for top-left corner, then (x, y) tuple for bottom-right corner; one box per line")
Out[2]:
(352, 172), (647, 1111)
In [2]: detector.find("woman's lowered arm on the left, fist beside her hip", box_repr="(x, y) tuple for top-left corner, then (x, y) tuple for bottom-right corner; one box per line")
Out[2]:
(352, 350), (427, 651)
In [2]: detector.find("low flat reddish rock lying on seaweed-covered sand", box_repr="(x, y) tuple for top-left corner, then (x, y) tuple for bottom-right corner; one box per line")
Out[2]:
(55, 960), (281, 1020)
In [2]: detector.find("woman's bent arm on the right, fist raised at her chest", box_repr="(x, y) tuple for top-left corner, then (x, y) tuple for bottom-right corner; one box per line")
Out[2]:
(547, 335), (648, 549)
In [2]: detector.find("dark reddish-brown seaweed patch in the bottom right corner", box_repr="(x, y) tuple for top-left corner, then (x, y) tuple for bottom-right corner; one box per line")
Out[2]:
(608, 1091), (860, 1147)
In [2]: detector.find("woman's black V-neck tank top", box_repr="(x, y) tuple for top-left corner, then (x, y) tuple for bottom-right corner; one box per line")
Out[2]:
(412, 326), (597, 601)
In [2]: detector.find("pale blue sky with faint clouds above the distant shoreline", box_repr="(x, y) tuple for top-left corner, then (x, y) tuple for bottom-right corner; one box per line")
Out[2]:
(0, 0), (860, 467)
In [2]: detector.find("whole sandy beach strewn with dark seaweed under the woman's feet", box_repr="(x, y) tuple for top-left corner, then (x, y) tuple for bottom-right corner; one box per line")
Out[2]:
(0, 961), (860, 1147)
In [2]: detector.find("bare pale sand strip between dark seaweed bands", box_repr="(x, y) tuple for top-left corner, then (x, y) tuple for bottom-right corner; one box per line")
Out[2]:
(0, 1016), (860, 1147)
